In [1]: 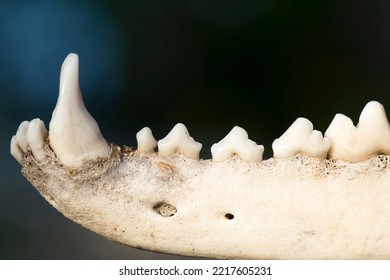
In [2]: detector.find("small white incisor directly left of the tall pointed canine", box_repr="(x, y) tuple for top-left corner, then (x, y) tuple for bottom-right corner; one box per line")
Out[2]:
(26, 119), (47, 161)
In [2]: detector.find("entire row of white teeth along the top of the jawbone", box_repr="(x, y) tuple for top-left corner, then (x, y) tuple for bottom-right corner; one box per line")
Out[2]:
(10, 54), (390, 168)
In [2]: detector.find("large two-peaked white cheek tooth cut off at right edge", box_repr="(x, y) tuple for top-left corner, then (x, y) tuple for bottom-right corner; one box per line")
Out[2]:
(325, 101), (390, 162)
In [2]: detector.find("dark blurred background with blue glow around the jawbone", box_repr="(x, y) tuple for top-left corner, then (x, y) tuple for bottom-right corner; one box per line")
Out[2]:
(0, 0), (390, 259)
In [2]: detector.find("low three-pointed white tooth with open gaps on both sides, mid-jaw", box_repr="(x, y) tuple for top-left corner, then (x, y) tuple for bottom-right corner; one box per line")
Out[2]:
(211, 126), (264, 162)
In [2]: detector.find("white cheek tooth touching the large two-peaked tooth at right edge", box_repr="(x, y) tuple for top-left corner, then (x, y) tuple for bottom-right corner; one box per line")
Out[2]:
(272, 118), (330, 158)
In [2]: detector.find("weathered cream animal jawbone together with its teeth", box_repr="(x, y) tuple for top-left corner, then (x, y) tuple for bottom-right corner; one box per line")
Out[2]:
(10, 55), (390, 259)
